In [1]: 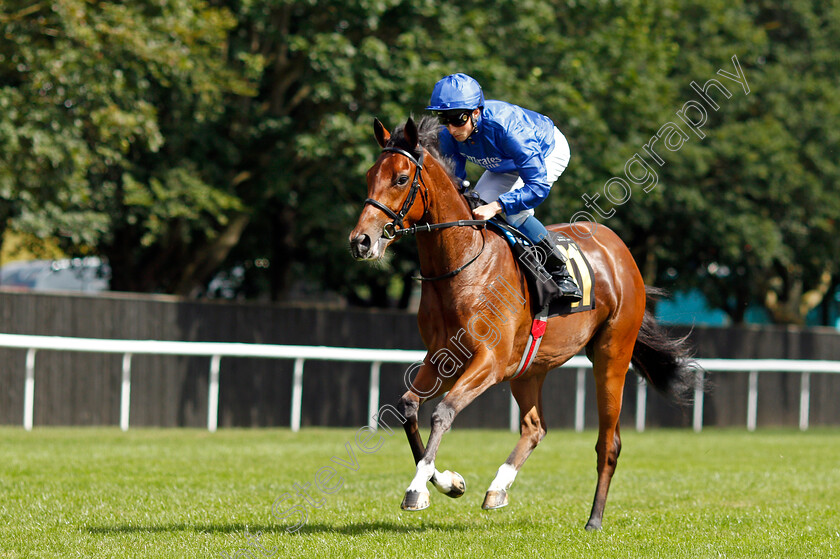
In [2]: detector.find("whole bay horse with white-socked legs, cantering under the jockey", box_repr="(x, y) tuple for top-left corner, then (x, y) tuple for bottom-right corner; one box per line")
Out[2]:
(350, 117), (694, 530)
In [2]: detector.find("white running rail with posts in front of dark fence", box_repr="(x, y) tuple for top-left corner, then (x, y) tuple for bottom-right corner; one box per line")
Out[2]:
(0, 334), (840, 432)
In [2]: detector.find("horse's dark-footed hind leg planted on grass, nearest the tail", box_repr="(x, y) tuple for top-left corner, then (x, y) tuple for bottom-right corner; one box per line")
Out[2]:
(586, 344), (633, 530)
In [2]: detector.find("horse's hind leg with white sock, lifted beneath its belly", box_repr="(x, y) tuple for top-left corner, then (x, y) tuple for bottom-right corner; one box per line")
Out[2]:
(481, 373), (546, 510)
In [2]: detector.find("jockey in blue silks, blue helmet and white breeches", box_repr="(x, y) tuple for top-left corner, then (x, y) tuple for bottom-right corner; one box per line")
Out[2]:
(426, 74), (581, 300)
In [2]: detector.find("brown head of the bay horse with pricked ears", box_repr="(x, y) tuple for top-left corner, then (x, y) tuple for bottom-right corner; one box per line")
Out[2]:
(350, 118), (425, 260)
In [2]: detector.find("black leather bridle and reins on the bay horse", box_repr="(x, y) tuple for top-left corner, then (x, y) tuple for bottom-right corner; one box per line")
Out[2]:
(365, 146), (487, 281)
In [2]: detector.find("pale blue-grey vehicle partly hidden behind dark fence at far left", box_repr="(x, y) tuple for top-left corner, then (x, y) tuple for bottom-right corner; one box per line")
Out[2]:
(0, 256), (111, 293)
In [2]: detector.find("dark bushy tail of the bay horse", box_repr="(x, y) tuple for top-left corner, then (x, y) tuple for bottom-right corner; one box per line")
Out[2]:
(632, 286), (699, 404)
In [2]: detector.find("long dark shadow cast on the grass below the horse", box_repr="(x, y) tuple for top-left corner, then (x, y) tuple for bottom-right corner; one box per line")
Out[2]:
(87, 520), (476, 536)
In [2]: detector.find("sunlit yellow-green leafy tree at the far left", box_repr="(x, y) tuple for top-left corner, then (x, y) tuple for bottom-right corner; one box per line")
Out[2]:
(0, 0), (250, 292)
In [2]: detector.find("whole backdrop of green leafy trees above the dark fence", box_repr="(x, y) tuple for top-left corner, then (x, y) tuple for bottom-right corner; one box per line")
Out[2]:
(0, 0), (840, 323)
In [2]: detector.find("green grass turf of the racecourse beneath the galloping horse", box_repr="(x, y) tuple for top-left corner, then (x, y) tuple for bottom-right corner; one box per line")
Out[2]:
(0, 427), (840, 559)
